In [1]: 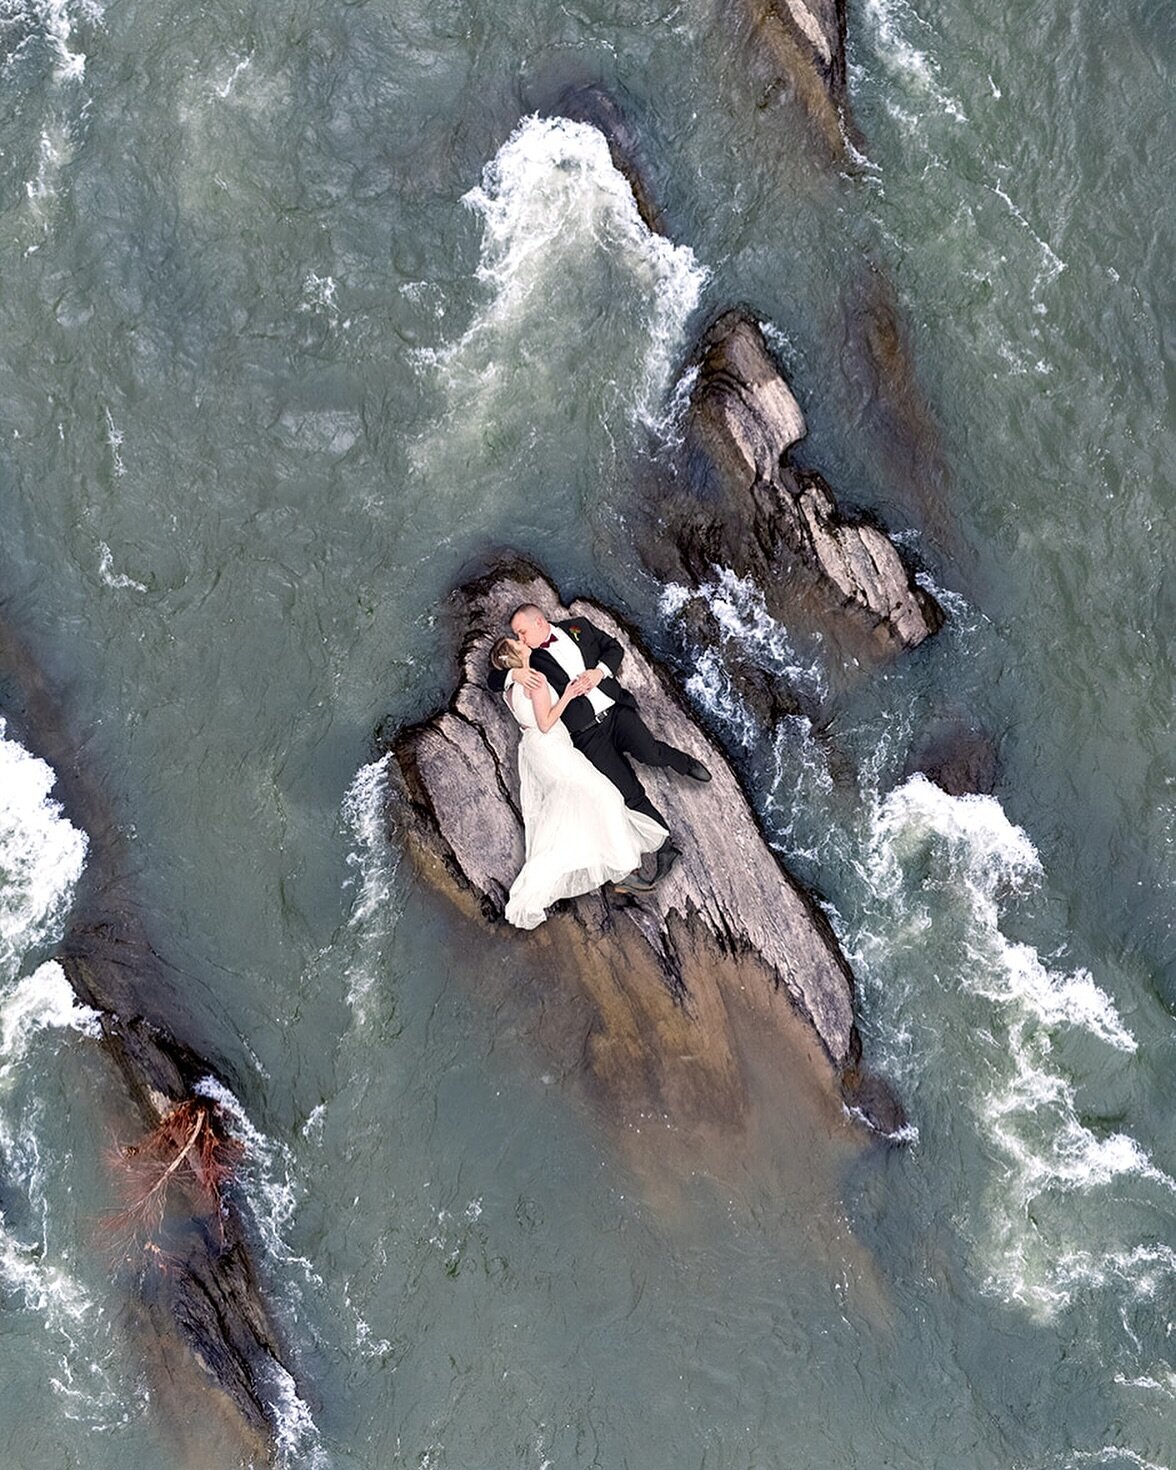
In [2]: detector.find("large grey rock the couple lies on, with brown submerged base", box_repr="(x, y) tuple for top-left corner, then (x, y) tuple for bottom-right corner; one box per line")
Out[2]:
(390, 562), (901, 1132)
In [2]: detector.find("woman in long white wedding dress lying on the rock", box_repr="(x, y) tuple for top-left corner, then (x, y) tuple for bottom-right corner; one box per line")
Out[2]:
(490, 638), (666, 929)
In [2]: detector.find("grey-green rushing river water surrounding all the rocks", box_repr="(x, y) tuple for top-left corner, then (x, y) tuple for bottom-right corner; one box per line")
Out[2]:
(0, 0), (1176, 1470)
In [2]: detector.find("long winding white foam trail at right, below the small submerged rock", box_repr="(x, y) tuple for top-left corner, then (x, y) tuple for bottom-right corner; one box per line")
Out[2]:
(864, 776), (1176, 1316)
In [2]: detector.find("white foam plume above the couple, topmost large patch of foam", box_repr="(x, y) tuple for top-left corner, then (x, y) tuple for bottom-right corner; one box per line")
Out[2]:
(416, 116), (706, 476)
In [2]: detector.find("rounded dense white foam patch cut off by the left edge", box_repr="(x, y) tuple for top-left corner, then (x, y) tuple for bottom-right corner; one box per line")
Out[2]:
(0, 719), (87, 978)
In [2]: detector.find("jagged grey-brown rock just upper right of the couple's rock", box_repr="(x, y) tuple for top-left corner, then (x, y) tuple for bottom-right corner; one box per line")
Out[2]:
(644, 312), (944, 653)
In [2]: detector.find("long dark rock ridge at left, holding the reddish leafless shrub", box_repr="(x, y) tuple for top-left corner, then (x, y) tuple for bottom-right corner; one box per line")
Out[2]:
(0, 623), (294, 1463)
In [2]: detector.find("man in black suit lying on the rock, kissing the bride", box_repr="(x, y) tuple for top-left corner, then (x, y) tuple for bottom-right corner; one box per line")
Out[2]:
(490, 603), (710, 886)
